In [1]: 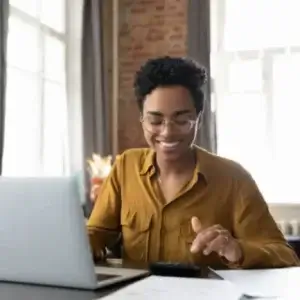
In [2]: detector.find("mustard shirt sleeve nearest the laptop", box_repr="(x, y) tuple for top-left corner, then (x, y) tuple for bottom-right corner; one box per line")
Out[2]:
(87, 156), (122, 259)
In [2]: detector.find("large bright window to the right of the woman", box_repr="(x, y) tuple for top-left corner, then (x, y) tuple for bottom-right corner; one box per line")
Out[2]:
(211, 0), (300, 203)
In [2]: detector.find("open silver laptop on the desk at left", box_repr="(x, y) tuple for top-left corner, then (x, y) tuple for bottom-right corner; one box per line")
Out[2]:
(0, 177), (148, 290)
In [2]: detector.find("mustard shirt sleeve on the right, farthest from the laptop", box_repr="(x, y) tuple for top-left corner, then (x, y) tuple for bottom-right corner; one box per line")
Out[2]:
(229, 174), (299, 268)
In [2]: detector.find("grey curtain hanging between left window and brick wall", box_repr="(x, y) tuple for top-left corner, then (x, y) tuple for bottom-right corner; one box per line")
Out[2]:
(81, 0), (112, 157)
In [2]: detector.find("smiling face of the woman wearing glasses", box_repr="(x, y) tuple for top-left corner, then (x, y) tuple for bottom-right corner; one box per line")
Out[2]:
(142, 86), (199, 160)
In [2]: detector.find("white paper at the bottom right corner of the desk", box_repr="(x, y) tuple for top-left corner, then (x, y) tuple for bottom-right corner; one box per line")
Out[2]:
(214, 267), (300, 300)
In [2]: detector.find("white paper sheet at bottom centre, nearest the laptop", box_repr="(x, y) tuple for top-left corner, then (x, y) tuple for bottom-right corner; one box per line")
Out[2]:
(103, 276), (243, 300)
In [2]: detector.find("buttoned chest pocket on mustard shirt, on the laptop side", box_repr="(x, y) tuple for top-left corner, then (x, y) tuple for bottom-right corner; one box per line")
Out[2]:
(121, 210), (152, 262)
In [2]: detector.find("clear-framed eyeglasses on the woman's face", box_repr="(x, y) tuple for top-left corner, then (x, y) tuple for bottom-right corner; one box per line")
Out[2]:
(141, 116), (197, 134)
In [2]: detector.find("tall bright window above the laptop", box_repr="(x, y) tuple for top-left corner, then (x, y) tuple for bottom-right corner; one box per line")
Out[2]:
(3, 0), (68, 176)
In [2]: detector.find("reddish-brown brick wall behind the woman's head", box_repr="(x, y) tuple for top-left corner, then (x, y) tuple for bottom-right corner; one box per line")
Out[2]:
(118, 0), (188, 152)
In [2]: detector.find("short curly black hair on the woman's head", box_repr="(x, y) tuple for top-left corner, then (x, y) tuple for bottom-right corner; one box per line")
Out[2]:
(134, 56), (207, 114)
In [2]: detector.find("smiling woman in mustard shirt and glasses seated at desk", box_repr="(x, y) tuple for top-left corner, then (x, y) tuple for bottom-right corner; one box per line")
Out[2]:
(88, 57), (298, 268)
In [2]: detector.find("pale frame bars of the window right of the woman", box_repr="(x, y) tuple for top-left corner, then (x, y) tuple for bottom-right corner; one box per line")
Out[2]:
(211, 0), (300, 205)
